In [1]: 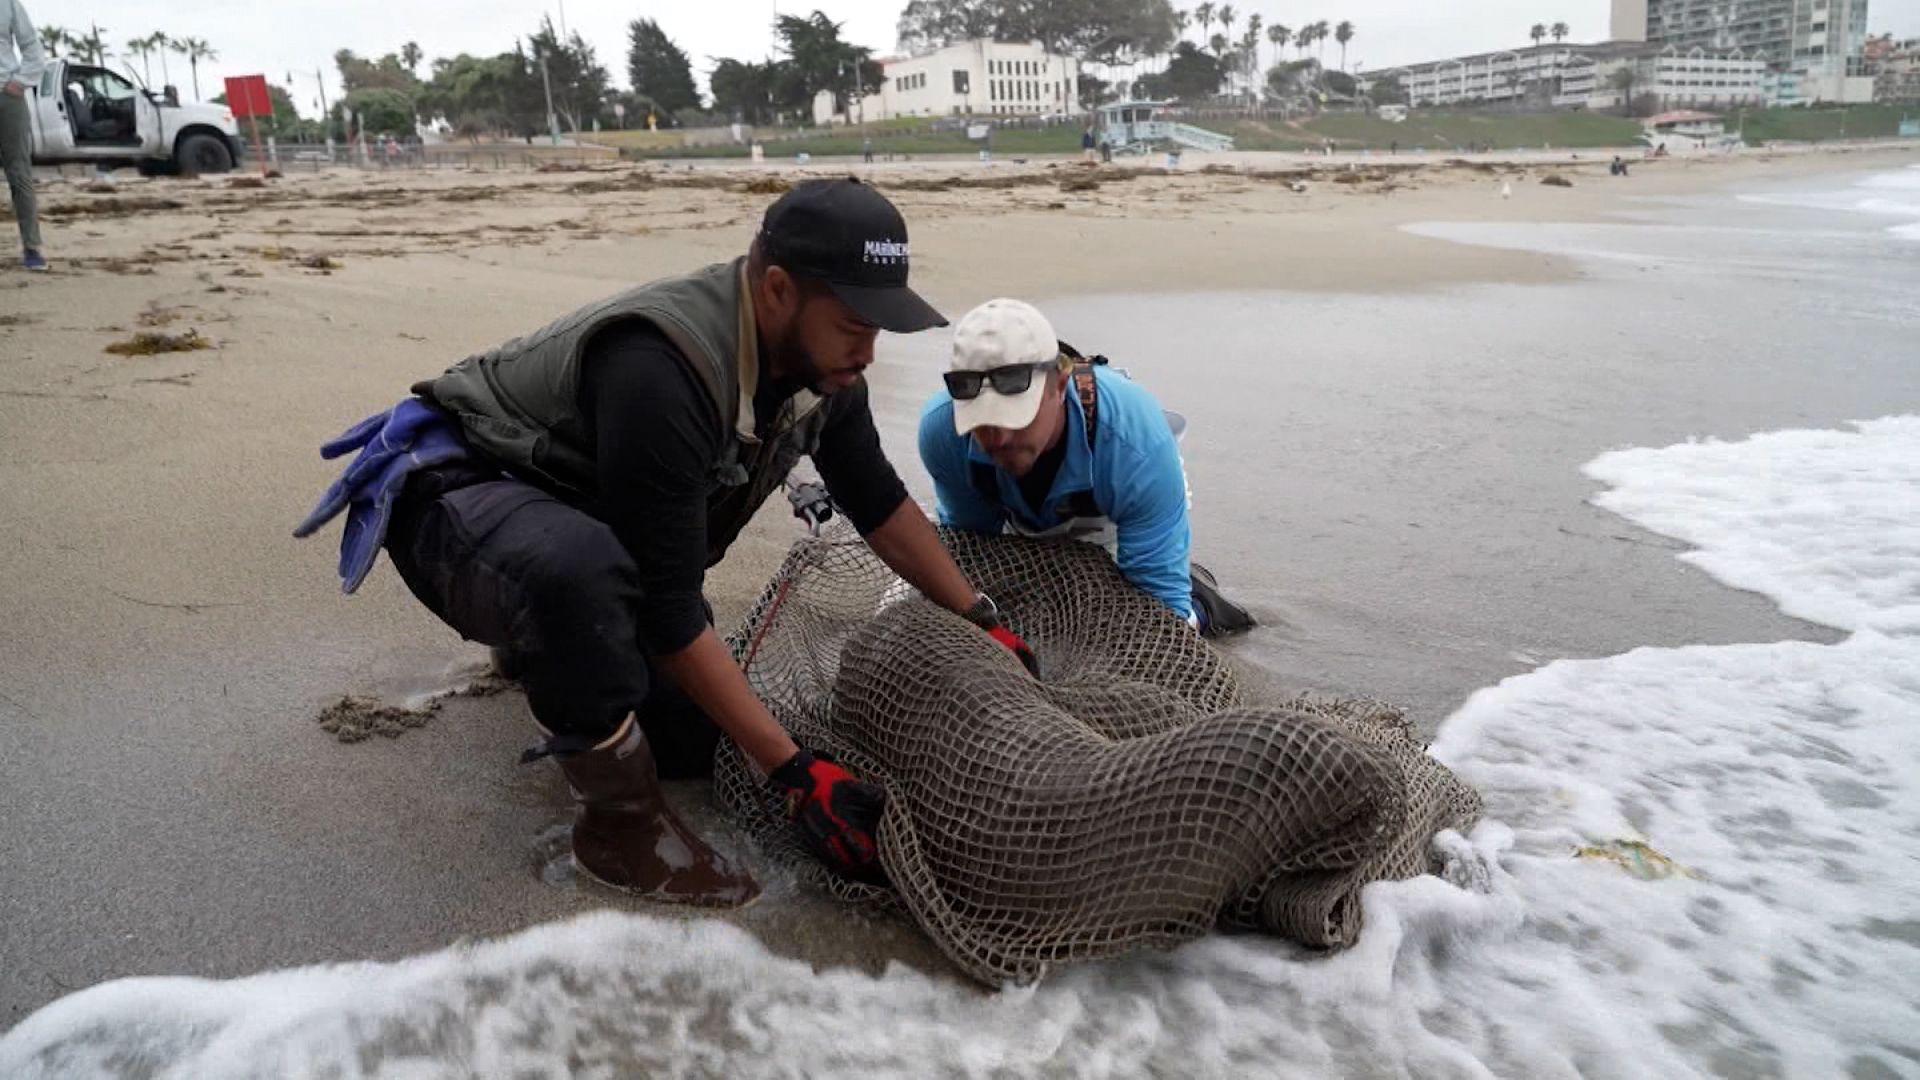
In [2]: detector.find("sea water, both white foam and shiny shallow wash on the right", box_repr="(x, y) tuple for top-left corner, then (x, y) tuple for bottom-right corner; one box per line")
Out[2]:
(0, 164), (1920, 1080)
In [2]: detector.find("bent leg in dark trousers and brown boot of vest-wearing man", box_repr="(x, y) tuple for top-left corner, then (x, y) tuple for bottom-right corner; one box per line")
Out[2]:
(388, 469), (758, 907)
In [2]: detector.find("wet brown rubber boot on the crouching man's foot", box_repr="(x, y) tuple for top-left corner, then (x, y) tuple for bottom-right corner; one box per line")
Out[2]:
(555, 717), (760, 907)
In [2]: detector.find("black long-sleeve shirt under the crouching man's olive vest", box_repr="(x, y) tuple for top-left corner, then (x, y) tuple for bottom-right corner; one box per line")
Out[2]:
(580, 321), (906, 655)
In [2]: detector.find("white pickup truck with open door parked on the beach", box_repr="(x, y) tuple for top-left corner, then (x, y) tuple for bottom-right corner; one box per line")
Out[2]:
(27, 60), (240, 175)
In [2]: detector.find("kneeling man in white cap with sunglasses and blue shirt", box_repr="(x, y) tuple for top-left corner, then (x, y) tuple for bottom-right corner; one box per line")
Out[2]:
(920, 300), (1200, 626)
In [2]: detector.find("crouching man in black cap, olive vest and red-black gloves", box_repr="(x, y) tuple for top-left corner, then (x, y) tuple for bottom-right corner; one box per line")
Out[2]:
(296, 181), (1035, 907)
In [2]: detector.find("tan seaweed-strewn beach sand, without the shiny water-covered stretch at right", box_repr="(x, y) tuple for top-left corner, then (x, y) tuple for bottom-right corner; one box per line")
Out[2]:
(0, 141), (1912, 1028)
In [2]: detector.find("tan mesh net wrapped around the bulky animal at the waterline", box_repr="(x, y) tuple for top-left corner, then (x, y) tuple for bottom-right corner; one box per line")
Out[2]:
(716, 528), (1480, 984)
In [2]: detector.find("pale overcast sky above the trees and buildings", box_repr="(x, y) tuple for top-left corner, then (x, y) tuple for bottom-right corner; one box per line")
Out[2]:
(37, 0), (1920, 115)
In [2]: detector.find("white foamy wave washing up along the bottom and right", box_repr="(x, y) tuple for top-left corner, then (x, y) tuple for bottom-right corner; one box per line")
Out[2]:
(11, 417), (1920, 1080)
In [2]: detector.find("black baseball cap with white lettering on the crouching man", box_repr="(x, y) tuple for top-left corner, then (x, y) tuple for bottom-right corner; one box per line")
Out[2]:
(760, 179), (947, 334)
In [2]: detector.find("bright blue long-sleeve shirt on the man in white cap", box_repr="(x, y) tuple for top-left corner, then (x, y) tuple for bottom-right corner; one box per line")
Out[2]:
(920, 367), (1194, 619)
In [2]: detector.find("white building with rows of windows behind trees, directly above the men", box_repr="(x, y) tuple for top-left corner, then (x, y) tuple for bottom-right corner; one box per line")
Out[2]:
(814, 38), (1085, 123)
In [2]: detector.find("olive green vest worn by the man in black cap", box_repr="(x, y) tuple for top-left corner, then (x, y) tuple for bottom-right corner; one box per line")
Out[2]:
(413, 259), (828, 567)
